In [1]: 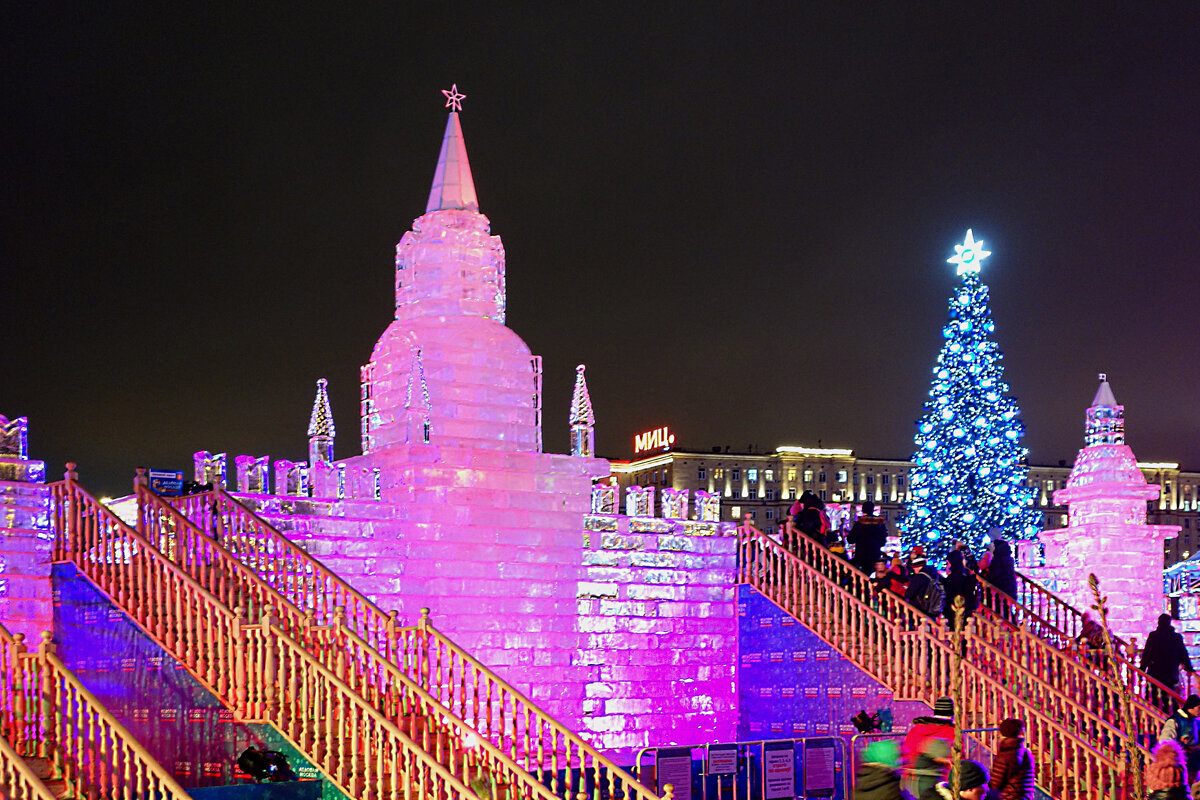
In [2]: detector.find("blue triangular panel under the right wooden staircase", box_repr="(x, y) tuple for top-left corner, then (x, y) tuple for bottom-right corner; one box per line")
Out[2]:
(737, 585), (931, 741)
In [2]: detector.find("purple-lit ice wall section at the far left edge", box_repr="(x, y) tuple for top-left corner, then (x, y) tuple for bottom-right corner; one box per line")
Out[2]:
(0, 479), (54, 646)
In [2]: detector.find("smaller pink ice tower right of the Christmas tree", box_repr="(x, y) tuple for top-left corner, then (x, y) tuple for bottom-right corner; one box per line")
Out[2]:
(1040, 375), (1180, 640)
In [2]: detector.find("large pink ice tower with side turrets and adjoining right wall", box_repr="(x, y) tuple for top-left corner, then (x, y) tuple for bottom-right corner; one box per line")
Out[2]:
(284, 101), (737, 748)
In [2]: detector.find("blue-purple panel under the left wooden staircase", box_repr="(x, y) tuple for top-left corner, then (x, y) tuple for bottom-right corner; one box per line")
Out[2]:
(54, 564), (344, 800)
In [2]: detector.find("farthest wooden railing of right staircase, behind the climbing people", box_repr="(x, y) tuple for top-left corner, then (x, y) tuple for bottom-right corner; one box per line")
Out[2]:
(978, 573), (1183, 723)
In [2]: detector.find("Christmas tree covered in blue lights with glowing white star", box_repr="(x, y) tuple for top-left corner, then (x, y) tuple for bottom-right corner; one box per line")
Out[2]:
(900, 230), (1040, 563)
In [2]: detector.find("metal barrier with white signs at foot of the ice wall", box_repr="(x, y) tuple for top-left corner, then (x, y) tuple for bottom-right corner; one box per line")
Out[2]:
(634, 736), (851, 800)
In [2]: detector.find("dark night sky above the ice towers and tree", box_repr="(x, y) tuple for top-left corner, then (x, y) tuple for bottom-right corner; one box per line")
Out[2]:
(0, 2), (1200, 494)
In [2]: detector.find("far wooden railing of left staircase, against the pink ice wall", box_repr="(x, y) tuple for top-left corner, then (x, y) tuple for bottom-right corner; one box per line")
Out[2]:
(172, 487), (658, 800)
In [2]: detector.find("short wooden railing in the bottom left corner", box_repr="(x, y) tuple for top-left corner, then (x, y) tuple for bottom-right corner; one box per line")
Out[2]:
(0, 626), (188, 800)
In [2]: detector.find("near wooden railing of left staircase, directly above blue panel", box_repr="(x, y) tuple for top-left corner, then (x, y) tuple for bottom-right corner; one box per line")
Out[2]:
(50, 473), (501, 800)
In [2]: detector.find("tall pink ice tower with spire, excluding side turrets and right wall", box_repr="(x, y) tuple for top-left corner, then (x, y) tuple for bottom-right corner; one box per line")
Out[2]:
(321, 106), (610, 722)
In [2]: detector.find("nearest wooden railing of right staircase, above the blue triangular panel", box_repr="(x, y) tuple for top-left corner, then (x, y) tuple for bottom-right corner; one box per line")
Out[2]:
(738, 523), (1147, 799)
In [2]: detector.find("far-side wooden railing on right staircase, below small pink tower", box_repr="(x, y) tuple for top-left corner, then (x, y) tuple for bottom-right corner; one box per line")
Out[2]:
(979, 572), (1186, 714)
